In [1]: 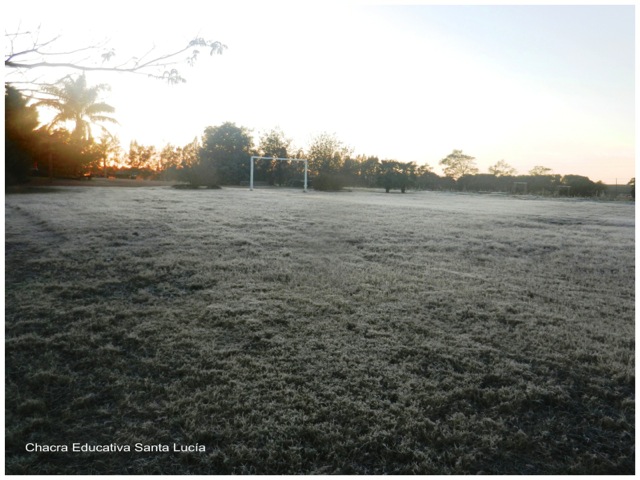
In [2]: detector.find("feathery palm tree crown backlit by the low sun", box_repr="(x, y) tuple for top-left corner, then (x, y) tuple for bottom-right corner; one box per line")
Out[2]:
(34, 74), (118, 142)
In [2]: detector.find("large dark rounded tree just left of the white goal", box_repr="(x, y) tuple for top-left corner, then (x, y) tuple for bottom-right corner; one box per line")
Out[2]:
(199, 122), (253, 186)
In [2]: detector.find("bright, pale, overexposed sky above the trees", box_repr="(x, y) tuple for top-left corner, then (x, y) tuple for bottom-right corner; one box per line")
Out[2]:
(2, 0), (636, 183)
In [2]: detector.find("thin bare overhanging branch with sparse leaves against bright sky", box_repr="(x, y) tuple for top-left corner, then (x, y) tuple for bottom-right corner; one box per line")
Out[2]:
(4, 27), (227, 93)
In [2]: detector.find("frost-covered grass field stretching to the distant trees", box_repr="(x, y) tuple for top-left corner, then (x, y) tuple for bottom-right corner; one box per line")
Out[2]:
(5, 187), (635, 474)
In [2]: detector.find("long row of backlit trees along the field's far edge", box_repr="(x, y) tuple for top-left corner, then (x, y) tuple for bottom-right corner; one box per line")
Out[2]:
(5, 83), (633, 196)
